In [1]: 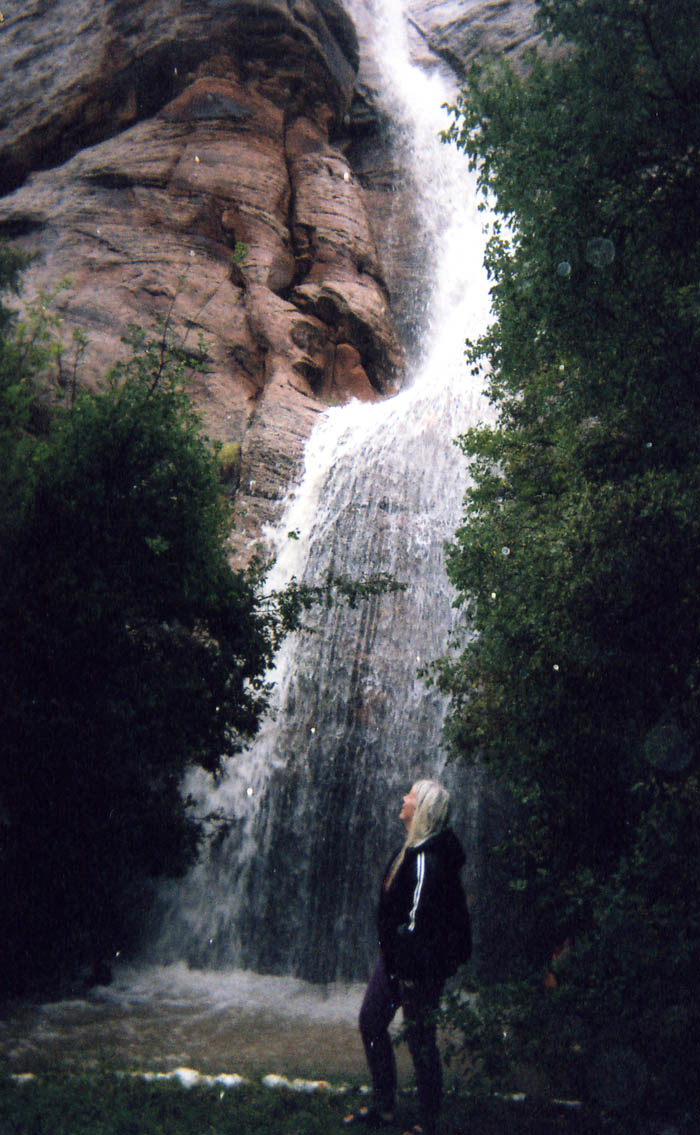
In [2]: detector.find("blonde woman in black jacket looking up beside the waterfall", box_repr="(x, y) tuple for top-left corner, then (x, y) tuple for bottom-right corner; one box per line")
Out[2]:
(345, 780), (471, 1135)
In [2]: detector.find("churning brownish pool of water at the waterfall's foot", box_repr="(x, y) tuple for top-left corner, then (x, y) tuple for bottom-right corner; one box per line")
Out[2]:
(0, 965), (411, 1084)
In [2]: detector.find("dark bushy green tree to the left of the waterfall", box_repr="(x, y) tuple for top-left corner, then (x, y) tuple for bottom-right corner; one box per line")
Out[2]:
(0, 276), (281, 992)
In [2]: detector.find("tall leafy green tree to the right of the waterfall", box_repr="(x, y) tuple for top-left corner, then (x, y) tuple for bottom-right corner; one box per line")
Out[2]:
(439, 0), (700, 1121)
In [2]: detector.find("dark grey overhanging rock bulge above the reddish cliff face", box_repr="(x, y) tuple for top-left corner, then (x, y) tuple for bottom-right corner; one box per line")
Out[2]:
(0, 0), (357, 192)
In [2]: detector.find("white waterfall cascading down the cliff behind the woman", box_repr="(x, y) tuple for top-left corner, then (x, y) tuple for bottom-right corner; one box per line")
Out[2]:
(152, 0), (489, 982)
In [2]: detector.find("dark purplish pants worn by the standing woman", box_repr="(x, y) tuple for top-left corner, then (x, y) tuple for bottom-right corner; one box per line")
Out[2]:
(360, 958), (442, 1132)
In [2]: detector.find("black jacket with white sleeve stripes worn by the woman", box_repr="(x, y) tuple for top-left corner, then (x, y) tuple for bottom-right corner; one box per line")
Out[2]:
(378, 827), (471, 981)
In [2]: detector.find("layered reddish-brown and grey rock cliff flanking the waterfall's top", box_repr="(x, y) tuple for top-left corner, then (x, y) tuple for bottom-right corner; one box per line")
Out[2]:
(0, 0), (533, 561)
